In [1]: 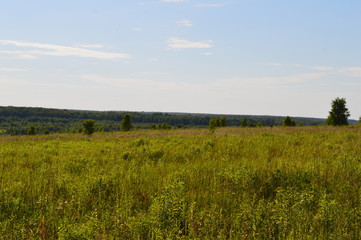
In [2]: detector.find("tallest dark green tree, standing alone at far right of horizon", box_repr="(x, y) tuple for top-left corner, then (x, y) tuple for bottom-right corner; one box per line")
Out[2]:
(326, 98), (350, 126)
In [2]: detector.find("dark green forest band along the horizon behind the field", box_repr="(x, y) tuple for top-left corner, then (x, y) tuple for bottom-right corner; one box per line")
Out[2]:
(0, 107), (324, 135)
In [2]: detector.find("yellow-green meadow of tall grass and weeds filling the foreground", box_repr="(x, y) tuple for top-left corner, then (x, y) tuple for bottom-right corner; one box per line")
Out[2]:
(0, 127), (361, 239)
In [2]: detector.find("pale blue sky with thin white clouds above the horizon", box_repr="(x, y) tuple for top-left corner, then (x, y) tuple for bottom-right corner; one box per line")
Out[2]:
(0, 0), (361, 119)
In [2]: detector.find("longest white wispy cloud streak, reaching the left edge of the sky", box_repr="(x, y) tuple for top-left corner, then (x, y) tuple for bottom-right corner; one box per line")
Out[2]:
(0, 40), (130, 60)
